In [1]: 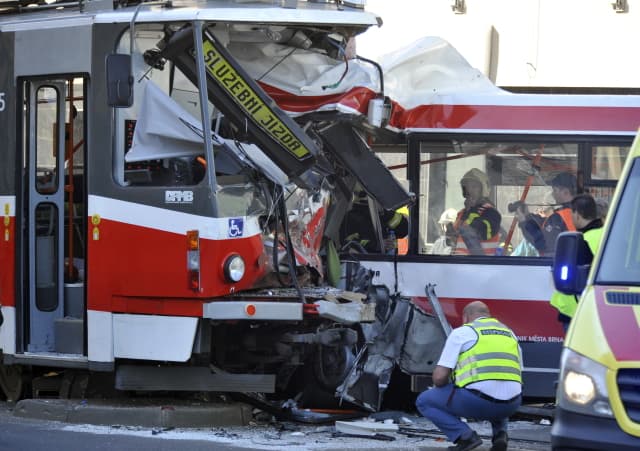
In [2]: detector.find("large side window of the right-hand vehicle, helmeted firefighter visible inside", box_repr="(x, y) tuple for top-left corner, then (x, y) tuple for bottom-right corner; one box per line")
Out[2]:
(419, 140), (581, 257)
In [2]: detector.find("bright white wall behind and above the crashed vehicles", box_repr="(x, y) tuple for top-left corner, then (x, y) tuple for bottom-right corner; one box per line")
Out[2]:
(357, 0), (640, 88)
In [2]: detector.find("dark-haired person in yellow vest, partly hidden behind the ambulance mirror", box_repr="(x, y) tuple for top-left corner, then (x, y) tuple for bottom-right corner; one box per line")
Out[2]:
(551, 194), (603, 333)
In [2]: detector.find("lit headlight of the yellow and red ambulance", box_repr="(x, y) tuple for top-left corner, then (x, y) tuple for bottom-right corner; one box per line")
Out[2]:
(557, 348), (613, 417)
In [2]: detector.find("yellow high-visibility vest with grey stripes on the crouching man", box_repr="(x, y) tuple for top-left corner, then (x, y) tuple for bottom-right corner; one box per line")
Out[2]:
(453, 318), (522, 387)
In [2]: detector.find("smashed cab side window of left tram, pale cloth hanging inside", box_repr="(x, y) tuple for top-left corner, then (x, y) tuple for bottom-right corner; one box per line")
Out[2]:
(114, 24), (211, 186)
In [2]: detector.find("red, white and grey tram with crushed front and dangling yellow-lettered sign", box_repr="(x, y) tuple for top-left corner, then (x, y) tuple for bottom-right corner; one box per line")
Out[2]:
(0, 0), (444, 410)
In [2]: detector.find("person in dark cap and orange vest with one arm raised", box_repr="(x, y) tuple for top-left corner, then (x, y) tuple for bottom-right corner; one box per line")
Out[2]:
(515, 172), (577, 256)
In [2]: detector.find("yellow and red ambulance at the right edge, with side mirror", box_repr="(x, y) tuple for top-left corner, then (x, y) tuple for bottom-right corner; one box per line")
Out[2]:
(551, 129), (640, 450)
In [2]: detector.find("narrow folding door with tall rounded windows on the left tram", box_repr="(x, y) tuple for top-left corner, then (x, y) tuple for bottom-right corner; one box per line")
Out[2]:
(22, 77), (86, 354)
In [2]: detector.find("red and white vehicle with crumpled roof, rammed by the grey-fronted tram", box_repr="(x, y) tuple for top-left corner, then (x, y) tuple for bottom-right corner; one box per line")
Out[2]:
(358, 37), (640, 400)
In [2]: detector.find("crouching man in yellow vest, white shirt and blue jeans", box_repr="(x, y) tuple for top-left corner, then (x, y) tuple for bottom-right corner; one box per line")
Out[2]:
(416, 301), (522, 451)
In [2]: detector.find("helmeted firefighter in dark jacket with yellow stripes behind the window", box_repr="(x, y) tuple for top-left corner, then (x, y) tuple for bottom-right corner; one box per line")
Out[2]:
(453, 168), (502, 255)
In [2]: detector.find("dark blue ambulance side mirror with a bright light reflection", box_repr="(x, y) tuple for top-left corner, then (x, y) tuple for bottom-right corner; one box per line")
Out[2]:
(551, 232), (593, 295)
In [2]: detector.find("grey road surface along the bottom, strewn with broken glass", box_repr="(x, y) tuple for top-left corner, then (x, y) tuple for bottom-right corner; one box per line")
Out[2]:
(0, 403), (550, 451)
